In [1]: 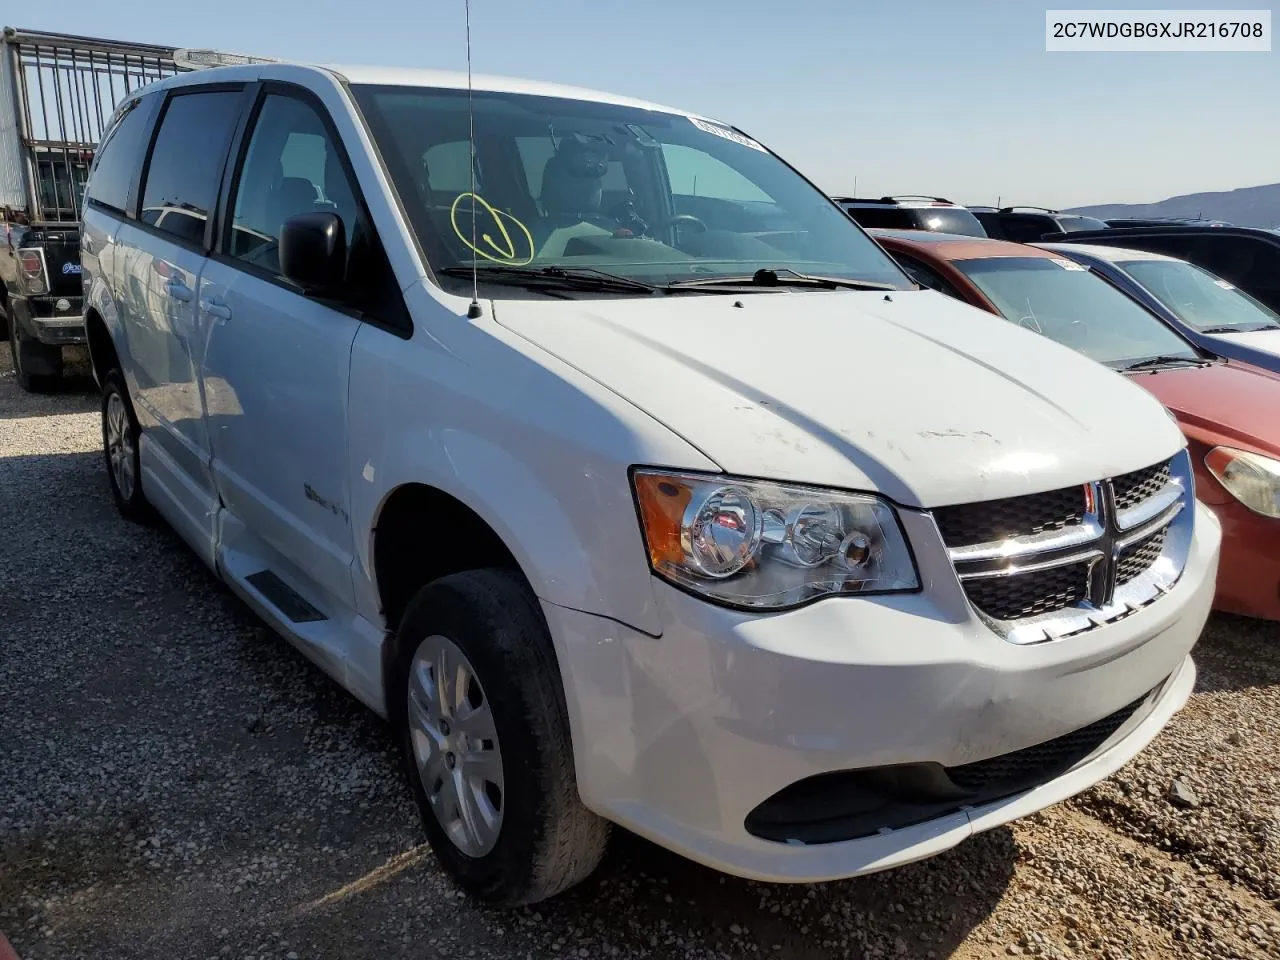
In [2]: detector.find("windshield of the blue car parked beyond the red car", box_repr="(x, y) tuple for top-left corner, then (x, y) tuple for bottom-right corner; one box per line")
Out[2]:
(1116, 260), (1280, 333)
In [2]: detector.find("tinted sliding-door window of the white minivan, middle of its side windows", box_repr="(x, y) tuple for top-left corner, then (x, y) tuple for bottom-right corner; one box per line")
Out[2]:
(142, 90), (241, 243)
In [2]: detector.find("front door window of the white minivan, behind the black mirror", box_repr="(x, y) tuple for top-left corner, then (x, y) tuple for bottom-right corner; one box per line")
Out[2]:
(230, 93), (358, 274)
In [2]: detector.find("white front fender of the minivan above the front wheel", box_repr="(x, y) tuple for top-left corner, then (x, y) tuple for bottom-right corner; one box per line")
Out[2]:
(349, 285), (716, 634)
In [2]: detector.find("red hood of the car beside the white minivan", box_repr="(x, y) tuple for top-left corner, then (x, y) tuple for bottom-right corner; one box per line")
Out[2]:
(1130, 364), (1280, 457)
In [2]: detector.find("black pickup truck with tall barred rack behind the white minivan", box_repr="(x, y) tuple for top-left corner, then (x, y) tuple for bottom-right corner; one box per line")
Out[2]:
(0, 27), (179, 390)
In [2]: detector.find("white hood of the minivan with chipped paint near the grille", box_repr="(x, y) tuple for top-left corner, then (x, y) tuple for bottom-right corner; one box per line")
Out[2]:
(494, 291), (1183, 507)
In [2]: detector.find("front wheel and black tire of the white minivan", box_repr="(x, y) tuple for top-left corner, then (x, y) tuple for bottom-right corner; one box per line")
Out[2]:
(389, 570), (609, 906)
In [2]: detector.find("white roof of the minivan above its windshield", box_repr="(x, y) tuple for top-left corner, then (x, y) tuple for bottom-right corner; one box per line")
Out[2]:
(140, 60), (701, 123)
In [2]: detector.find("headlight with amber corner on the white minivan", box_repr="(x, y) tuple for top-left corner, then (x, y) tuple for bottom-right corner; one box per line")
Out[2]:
(634, 470), (919, 609)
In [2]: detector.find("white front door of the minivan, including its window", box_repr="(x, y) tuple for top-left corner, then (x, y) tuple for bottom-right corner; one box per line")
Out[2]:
(200, 86), (360, 612)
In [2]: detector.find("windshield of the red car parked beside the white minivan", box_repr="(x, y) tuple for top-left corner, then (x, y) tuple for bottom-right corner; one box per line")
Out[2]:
(956, 257), (1198, 367)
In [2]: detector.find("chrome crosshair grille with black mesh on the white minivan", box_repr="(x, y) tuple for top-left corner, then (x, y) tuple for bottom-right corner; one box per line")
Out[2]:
(933, 451), (1194, 644)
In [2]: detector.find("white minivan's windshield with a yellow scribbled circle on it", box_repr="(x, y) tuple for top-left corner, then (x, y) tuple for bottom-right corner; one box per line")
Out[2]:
(353, 84), (913, 297)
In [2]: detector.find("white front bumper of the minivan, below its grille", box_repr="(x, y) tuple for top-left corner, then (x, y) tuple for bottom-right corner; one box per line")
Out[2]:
(543, 507), (1221, 881)
